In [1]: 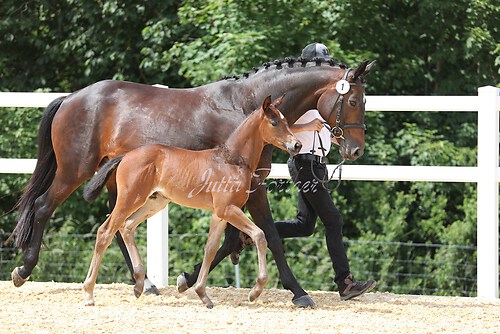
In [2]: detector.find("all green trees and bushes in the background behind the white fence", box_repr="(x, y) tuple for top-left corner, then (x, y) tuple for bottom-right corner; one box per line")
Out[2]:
(0, 0), (500, 295)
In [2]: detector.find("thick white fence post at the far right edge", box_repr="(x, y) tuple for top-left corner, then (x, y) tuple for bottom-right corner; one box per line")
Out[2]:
(477, 86), (500, 298)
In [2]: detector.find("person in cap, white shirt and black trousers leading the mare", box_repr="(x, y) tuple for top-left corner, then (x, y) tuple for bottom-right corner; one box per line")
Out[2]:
(276, 43), (376, 300)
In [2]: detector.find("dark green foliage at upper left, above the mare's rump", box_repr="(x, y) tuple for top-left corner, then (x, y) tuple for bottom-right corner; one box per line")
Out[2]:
(0, 0), (177, 91)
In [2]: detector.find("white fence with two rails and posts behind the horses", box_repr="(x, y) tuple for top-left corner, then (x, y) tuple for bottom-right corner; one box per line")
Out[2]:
(0, 86), (500, 298)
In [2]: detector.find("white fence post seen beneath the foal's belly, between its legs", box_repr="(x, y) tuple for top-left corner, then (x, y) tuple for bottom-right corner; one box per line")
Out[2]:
(146, 205), (168, 288)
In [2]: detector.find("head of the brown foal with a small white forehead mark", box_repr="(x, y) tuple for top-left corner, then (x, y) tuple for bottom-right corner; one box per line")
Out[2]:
(259, 96), (302, 155)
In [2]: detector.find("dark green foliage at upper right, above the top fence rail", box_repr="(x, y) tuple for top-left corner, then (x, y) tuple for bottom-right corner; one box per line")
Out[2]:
(334, 0), (500, 95)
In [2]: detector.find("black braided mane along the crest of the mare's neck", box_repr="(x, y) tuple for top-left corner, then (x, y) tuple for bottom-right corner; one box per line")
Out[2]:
(220, 57), (348, 80)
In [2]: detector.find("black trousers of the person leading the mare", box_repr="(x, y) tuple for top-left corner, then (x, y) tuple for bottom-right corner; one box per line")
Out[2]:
(276, 158), (350, 284)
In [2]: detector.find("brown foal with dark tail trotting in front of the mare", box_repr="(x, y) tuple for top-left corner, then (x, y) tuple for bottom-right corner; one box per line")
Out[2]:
(83, 96), (302, 308)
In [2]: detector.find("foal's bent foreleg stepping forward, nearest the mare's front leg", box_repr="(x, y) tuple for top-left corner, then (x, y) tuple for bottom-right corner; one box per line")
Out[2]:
(218, 205), (268, 302)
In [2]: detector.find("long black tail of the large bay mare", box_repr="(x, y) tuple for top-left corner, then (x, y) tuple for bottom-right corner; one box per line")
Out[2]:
(6, 96), (66, 250)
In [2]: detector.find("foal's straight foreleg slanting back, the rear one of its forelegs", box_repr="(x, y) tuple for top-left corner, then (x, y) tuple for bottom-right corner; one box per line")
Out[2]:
(194, 213), (227, 308)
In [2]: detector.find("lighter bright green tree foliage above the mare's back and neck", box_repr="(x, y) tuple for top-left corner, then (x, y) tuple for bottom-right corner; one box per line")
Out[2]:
(143, 0), (344, 85)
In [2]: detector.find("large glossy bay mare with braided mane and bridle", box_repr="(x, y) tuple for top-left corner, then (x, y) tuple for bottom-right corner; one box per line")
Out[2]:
(12, 58), (373, 306)
